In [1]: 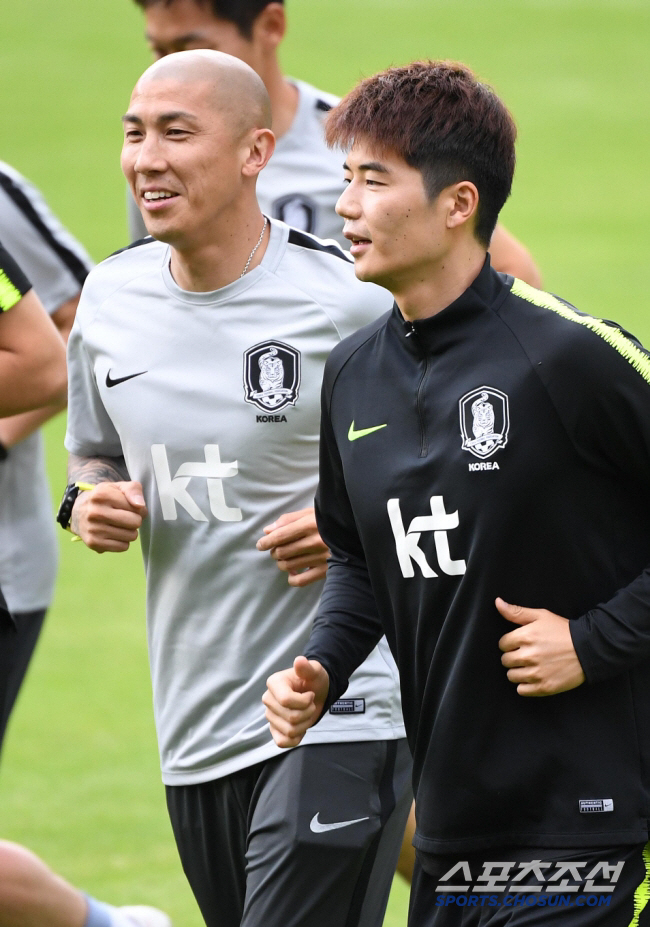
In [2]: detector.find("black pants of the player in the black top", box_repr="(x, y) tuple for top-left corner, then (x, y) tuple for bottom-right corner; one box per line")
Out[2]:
(408, 844), (650, 927)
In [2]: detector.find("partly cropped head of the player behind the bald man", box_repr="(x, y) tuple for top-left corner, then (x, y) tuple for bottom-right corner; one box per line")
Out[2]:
(135, 0), (286, 78)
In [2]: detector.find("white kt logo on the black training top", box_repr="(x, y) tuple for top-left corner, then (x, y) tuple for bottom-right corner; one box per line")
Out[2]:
(388, 496), (466, 579)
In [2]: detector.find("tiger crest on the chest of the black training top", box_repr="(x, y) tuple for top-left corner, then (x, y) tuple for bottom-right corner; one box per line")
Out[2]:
(458, 386), (510, 460)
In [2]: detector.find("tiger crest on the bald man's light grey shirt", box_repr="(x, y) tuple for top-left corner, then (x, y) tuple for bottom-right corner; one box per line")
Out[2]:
(244, 341), (300, 413)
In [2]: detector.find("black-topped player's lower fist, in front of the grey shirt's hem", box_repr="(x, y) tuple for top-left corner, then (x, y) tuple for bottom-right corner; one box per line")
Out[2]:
(262, 657), (330, 747)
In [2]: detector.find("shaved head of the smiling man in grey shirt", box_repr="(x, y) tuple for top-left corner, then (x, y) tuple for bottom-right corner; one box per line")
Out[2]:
(122, 50), (274, 250)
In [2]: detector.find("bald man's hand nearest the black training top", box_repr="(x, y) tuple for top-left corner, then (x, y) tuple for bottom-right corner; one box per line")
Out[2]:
(256, 509), (329, 586)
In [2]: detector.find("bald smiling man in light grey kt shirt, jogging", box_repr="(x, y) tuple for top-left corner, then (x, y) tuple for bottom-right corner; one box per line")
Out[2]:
(59, 50), (411, 927)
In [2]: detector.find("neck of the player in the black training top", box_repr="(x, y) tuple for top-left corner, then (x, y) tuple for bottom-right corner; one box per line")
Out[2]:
(391, 238), (486, 322)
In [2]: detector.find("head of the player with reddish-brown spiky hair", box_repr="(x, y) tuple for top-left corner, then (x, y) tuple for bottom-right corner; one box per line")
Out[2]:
(326, 61), (516, 289)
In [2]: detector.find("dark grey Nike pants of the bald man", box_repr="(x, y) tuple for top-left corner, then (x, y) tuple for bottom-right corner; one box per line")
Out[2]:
(166, 740), (412, 927)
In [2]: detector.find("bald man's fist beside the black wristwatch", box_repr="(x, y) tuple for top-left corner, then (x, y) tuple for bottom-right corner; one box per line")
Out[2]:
(70, 480), (147, 554)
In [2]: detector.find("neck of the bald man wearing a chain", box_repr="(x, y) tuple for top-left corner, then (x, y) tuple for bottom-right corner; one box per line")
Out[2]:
(170, 204), (270, 293)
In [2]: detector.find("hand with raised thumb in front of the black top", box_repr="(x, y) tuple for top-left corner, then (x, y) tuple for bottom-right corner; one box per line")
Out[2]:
(495, 599), (585, 696)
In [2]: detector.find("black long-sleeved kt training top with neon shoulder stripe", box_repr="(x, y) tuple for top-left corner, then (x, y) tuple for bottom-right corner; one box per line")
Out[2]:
(306, 261), (650, 853)
